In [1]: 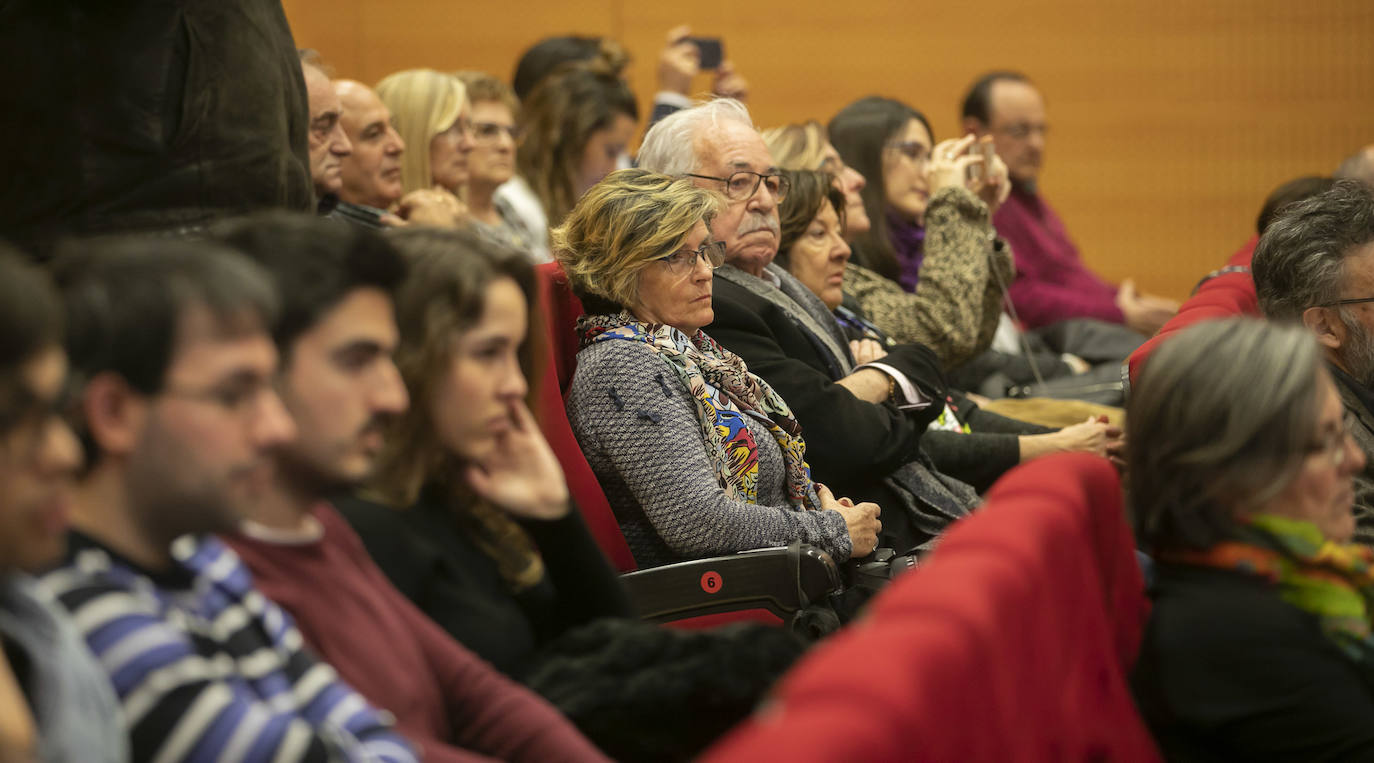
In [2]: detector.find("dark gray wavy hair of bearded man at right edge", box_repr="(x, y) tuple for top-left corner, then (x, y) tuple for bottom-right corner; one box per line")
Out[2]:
(1250, 180), (1374, 320)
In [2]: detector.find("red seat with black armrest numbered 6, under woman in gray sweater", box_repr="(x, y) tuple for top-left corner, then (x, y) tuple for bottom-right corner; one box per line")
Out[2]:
(534, 263), (841, 631)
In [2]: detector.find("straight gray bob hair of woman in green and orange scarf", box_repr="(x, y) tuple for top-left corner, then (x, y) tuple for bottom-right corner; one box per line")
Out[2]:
(1127, 318), (1323, 553)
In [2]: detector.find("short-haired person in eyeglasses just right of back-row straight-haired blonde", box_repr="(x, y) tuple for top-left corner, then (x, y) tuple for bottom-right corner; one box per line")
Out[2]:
(455, 71), (535, 254)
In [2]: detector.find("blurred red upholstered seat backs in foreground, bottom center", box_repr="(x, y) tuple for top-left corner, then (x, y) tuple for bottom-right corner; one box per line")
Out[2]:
(702, 454), (1160, 763)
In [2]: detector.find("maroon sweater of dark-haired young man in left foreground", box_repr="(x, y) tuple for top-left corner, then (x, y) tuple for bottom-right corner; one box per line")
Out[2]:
(225, 503), (606, 762)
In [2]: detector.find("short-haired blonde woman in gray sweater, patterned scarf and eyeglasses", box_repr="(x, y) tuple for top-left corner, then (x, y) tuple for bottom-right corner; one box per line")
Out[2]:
(552, 169), (881, 566)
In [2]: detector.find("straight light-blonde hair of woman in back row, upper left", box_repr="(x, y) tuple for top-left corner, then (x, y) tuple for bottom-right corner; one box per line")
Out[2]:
(375, 69), (467, 194)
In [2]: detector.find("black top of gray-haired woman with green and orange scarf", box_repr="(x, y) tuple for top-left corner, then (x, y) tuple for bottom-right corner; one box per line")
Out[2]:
(1134, 564), (1374, 762)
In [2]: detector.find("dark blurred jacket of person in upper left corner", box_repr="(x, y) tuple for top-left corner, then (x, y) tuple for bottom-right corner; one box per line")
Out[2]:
(0, 0), (312, 256)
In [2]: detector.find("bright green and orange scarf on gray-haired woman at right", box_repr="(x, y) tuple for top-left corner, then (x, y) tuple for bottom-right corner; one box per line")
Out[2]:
(1164, 514), (1374, 663)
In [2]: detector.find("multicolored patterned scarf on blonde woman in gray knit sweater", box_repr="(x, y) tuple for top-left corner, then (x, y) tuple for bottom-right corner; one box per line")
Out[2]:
(577, 312), (819, 509)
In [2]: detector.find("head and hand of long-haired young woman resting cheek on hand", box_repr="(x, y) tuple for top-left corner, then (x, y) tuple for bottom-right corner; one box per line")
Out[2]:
(375, 228), (569, 580)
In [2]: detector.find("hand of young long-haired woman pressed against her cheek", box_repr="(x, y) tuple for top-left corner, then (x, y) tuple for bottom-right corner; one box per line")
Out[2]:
(466, 400), (569, 520)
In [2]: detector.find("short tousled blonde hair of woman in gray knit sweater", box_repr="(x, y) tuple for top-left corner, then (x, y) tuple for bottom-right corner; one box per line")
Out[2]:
(550, 168), (724, 312)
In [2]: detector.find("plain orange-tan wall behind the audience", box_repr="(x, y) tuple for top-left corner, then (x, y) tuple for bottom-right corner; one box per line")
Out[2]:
(284, 0), (1374, 297)
